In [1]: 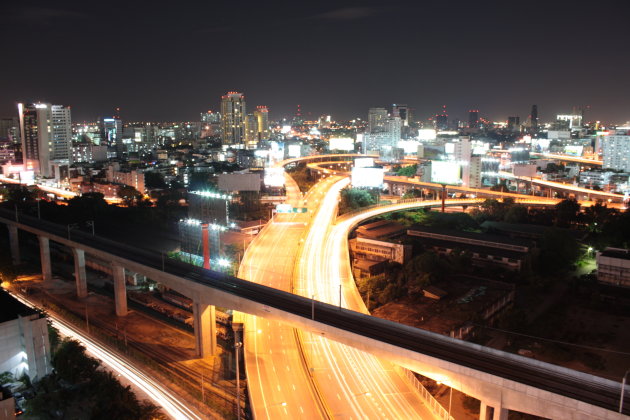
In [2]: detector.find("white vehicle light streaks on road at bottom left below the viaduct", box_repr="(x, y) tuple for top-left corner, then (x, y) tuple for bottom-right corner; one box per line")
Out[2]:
(11, 293), (203, 420)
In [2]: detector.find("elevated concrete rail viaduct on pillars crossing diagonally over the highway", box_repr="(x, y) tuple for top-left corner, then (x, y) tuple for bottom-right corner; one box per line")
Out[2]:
(0, 209), (630, 420)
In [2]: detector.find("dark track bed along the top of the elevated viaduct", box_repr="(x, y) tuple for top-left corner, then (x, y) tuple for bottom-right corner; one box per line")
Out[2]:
(0, 203), (630, 414)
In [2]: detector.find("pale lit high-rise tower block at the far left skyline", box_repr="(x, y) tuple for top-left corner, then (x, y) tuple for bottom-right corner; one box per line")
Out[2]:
(18, 103), (72, 177)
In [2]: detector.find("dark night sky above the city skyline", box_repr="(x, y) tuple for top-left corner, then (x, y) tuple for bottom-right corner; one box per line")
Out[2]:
(0, 0), (630, 123)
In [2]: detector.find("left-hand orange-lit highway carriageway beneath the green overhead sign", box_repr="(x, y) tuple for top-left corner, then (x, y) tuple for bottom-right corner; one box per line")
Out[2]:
(235, 175), (340, 419)
